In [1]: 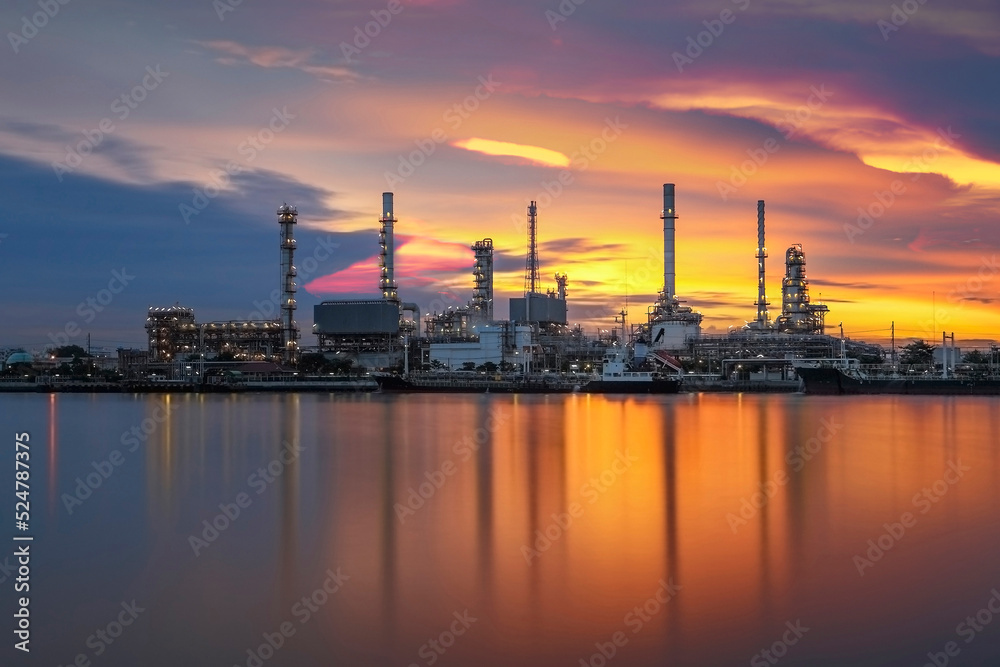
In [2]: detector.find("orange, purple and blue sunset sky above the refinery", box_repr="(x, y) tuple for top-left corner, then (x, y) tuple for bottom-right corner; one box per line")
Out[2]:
(0, 0), (1000, 350)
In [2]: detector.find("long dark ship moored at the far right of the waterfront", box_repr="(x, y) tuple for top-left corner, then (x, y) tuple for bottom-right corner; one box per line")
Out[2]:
(795, 363), (1000, 396)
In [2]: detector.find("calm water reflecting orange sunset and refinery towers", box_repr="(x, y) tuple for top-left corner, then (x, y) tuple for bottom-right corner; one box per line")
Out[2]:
(0, 395), (1000, 667)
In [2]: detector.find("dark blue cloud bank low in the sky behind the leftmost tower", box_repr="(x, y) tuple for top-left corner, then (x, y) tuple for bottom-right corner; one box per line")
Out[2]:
(0, 154), (364, 348)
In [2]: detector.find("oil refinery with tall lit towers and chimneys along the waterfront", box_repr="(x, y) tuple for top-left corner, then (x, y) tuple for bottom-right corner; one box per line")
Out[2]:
(31, 183), (882, 391)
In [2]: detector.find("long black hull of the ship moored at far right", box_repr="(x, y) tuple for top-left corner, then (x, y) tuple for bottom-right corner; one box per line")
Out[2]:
(796, 368), (1000, 396)
